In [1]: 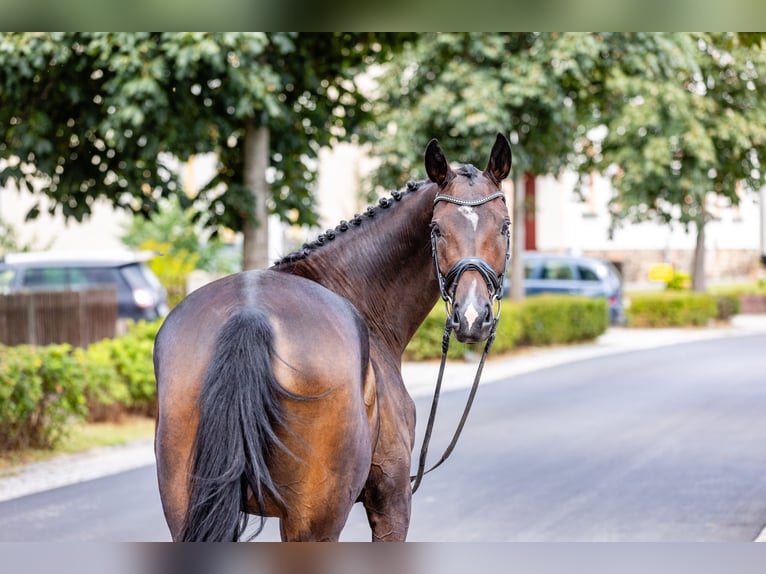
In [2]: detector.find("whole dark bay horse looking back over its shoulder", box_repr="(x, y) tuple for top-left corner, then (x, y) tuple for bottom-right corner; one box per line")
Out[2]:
(154, 134), (511, 541)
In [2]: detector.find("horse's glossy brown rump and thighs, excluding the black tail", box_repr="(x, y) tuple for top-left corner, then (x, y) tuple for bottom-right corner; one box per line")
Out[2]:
(154, 270), (374, 538)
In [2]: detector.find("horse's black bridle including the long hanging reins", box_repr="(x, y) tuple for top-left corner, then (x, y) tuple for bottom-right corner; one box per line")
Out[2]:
(410, 192), (510, 493)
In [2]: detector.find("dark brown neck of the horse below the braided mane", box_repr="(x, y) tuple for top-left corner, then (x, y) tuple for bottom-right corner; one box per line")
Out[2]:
(284, 184), (439, 354)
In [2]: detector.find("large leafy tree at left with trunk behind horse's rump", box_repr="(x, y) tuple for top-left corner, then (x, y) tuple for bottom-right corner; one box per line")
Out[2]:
(0, 33), (412, 268)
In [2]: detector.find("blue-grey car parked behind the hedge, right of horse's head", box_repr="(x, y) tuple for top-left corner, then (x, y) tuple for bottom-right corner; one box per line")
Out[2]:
(505, 251), (625, 325)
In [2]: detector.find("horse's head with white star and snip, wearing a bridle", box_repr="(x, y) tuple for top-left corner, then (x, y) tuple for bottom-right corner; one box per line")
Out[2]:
(425, 134), (511, 343)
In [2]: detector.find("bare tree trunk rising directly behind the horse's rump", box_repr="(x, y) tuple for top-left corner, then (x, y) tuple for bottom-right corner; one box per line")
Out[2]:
(242, 120), (271, 269)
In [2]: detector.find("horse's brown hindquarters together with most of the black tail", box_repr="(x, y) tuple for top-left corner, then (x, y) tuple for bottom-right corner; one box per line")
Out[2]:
(155, 271), (372, 539)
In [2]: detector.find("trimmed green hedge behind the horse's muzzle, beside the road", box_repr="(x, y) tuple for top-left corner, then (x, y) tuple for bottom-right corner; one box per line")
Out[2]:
(404, 295), (609, 360)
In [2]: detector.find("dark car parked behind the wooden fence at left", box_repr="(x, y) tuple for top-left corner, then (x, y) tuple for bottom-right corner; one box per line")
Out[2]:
(0, 251), (168, 321)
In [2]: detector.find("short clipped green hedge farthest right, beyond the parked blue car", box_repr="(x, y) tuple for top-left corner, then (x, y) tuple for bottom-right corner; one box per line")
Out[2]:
(627, 291), (719, 327)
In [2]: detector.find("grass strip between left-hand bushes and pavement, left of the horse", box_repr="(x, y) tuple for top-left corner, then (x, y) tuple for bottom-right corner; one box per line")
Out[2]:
(0, 416), (154, 478)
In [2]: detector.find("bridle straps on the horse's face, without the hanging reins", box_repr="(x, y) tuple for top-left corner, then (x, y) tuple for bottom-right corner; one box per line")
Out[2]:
(431, 191), (511, 322)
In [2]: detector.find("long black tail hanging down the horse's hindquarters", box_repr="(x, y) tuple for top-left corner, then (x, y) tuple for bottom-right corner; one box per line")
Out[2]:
(180, 310), (297, 541)
